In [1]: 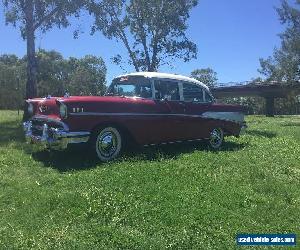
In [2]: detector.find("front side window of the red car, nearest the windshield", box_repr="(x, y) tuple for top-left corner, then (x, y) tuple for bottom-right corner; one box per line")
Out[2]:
(154, 80), (180, 101)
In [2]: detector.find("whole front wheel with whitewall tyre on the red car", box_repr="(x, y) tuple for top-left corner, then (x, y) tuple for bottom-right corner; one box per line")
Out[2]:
(94, 127), (122, 161)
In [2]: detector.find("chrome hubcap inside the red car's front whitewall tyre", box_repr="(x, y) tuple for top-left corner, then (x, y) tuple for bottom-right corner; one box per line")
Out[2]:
(98, 131), (117, 157)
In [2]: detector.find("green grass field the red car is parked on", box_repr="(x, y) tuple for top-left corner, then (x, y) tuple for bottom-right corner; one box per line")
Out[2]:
(0, 111), (300, 249)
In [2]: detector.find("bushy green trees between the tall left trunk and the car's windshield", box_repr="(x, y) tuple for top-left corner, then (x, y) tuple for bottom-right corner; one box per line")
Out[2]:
(37, 50), (106, 96)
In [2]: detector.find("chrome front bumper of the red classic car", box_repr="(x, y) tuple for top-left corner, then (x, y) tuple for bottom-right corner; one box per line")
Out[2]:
(23, 121), (90, 150)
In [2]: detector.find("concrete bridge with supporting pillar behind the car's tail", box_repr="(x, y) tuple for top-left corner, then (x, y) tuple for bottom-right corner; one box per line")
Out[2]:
(211, 82), (300, 116)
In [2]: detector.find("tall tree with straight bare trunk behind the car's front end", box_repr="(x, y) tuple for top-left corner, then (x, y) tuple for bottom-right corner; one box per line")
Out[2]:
(2, 0), (83, 98)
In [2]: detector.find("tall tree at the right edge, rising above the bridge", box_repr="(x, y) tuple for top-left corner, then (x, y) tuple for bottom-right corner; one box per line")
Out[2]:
(259, 0), (300, 83)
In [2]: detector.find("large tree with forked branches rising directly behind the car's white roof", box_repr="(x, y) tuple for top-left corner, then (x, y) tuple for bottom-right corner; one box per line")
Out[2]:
(89, 0), (198, 71)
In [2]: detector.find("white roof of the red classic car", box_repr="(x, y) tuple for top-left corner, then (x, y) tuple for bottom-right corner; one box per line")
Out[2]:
(116, 72), (208, 90)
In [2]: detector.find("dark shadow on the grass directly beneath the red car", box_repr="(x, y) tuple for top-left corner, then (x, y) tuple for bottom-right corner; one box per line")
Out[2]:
(32, 142), (246, 172)
